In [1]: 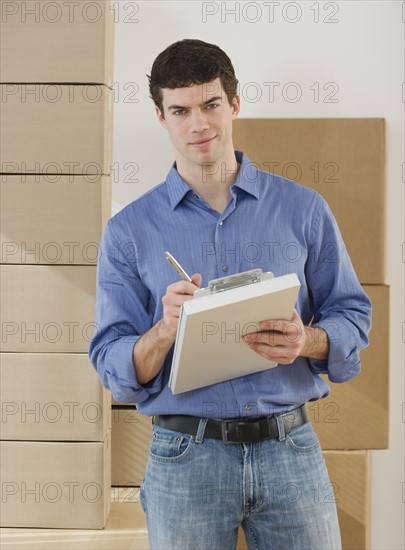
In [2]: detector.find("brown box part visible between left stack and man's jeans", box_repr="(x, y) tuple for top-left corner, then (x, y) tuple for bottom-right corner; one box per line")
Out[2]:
(111, 405), (152, 487)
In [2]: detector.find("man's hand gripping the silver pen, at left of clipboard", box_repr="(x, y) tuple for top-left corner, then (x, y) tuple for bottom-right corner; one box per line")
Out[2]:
(159, 273), (202, 343)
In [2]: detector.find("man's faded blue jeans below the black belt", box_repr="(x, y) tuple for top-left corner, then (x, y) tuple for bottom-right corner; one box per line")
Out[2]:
(140, 420), (341, 550)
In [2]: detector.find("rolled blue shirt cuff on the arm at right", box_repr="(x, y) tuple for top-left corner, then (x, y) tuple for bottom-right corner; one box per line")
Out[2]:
(308, 317), (360, 383)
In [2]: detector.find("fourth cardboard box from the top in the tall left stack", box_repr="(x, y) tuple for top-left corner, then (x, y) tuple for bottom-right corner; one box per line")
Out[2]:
(0, 265), (96, 353)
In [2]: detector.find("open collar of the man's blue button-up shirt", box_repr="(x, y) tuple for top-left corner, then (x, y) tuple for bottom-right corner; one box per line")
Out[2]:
(166, 151), (259, 210)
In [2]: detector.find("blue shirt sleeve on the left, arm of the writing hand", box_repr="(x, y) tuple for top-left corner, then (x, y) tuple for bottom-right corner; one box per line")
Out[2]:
(89, 220), (162, 403)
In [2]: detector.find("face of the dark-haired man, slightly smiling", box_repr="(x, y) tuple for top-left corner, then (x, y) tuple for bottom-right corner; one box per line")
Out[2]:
(156, 78), (240, 168)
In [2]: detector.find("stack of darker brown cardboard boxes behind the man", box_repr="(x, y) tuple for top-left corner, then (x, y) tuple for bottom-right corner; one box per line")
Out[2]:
(112, 119), (389, 549)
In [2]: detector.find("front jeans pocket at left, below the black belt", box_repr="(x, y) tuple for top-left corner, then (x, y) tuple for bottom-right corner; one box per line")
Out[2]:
(149, 425), (194, 462)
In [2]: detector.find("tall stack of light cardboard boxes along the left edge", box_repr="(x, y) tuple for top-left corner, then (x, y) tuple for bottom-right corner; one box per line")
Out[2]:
(0, 0), (114, 529)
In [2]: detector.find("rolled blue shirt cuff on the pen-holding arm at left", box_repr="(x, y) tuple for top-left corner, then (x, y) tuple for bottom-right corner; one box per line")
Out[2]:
(106, 336), (163, 403)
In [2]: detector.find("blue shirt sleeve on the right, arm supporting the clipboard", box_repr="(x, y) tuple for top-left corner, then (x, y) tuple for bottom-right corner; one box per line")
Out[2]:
(306, 195), (371, 382)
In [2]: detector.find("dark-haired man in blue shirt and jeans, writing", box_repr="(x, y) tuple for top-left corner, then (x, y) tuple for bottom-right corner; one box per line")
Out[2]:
(90, 36), (370, 550)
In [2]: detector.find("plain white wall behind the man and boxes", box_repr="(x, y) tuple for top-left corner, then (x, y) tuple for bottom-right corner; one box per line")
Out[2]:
(113, 0), (405, 550)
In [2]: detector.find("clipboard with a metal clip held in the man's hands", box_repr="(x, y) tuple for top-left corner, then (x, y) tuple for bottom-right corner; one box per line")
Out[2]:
(169, 269), (301, 395)
